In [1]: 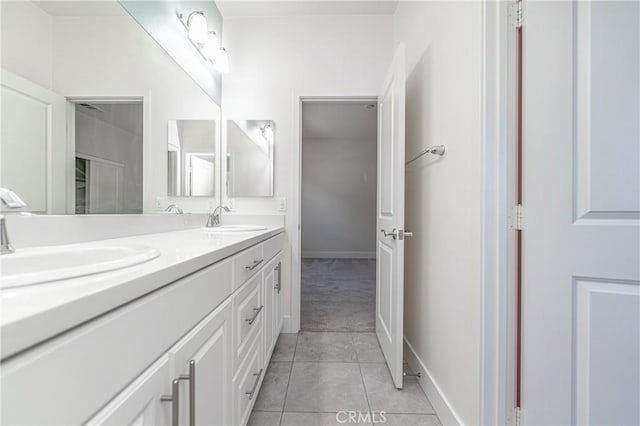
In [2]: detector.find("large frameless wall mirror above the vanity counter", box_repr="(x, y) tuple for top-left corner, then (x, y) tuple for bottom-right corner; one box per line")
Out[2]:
(0, 0), (222, 214)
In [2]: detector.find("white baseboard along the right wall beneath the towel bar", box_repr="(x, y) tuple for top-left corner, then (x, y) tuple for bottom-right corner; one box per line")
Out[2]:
(404, 337), (463, 426)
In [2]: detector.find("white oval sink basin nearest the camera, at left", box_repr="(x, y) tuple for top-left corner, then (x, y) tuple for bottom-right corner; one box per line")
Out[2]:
(0, 244), (160, 289)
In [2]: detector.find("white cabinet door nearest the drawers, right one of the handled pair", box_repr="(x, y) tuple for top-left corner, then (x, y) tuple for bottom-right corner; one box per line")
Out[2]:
(169, 300), (233, 425)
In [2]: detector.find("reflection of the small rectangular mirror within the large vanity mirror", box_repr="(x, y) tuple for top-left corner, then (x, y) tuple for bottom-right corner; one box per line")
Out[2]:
(167, 120), (216, 197)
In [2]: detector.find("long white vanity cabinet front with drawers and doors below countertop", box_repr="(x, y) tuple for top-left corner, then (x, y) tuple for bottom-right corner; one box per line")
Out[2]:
(0, 235), (283, 426)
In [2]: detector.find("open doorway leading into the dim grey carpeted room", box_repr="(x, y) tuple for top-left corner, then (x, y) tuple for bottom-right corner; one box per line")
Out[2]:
(300, 98), (377, 332)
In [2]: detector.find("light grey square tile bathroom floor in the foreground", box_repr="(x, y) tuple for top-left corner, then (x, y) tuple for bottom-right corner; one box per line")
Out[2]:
(249, 331), (440, 426)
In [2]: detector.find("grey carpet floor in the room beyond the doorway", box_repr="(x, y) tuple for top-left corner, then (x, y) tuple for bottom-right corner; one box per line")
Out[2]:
(300, 258), (376, 332)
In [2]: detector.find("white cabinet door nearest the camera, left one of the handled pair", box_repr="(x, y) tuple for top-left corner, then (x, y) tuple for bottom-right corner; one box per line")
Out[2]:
(87, 355), (172, 426)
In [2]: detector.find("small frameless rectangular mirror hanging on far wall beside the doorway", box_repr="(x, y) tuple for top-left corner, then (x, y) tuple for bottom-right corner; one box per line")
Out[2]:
(227, 120), (275, 197)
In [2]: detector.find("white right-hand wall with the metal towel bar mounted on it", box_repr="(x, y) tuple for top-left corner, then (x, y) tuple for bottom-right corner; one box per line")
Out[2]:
(394, 2), (482, 424)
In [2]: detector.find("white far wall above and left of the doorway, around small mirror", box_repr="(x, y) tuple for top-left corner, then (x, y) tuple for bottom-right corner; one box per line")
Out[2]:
(222, 15), (393, 330)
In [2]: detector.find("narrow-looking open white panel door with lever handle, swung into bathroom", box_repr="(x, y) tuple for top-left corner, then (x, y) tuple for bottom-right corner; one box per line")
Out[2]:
(376, 44), (406, 389)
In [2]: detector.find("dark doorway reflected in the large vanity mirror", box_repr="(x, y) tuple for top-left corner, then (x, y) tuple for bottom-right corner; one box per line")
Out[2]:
(75, 101), (142, 214)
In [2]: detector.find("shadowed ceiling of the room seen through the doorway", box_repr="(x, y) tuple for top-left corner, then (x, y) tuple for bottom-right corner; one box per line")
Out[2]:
(302, 102), (377, 140)
